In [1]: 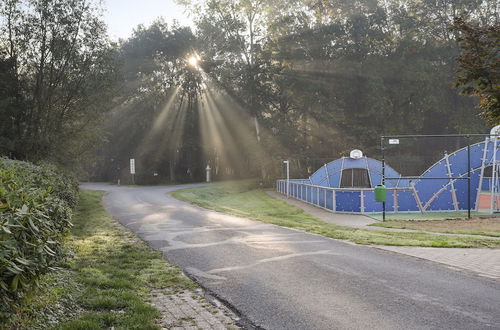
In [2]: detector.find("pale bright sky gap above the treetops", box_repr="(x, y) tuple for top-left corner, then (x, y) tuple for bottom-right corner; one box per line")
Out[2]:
(104, 0), (192, 40)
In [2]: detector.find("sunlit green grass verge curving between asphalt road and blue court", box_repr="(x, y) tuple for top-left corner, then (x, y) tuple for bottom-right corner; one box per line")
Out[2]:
(172, 183), (500, 248)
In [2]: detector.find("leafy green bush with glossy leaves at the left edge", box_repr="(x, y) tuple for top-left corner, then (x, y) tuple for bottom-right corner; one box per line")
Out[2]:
(0, 158), (78, 306)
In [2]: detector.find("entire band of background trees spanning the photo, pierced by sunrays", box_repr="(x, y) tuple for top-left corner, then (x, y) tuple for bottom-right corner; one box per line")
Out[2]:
(0, 0), (499, 183)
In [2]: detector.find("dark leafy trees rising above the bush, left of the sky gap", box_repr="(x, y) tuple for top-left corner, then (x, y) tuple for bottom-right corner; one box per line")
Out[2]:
(0, 0), (116, 168)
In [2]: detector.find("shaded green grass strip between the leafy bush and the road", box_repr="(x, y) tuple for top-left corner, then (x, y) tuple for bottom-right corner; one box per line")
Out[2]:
(6, 191), (196, 330)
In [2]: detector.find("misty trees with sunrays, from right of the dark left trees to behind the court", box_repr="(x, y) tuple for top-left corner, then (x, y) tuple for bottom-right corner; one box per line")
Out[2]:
(93, 0), (499, 183)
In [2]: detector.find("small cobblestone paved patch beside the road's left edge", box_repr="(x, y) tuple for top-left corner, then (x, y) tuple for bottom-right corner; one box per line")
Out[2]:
(151, 290), (240, 330)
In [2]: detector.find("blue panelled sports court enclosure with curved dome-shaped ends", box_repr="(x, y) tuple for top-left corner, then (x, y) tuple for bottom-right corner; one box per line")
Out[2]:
(277, 138), (500, 213)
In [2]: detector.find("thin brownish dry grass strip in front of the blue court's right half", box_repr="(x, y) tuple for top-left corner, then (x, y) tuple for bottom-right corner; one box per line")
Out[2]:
(371, 218), (500, 237)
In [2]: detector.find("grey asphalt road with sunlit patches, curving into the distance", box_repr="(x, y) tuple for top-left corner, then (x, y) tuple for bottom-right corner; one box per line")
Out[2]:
(84, 184), (500, 329)
